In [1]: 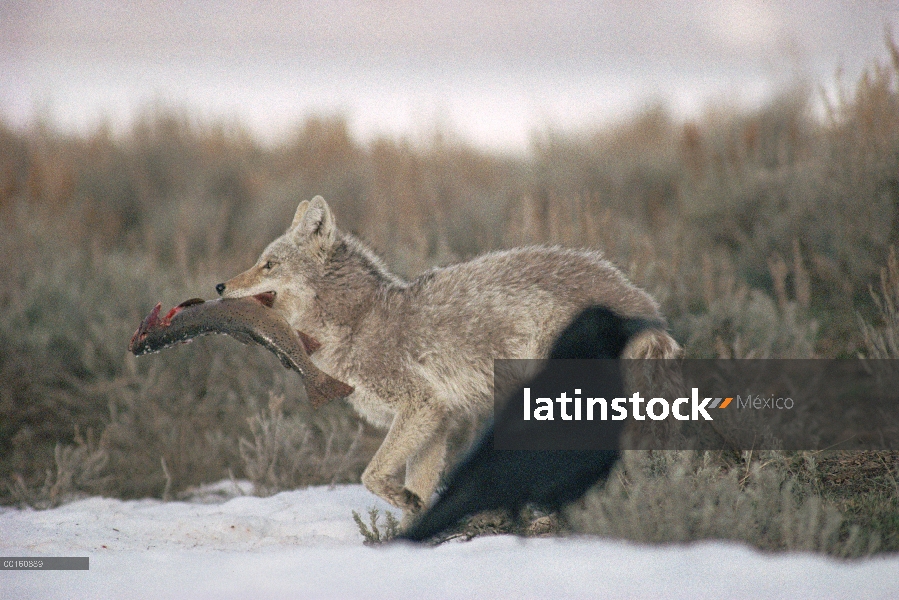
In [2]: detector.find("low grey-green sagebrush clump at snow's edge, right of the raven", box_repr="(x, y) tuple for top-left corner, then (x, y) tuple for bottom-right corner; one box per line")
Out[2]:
(567, 451), (881, 558)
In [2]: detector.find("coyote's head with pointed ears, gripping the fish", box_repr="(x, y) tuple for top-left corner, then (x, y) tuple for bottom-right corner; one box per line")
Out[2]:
(215, 196), (338, 321)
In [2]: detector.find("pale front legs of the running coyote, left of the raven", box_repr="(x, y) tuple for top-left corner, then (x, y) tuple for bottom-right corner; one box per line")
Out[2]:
(362, 404), (446, 514)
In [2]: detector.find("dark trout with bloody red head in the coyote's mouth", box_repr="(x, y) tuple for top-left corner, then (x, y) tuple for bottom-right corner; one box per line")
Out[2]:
(128, 293), (353, 407)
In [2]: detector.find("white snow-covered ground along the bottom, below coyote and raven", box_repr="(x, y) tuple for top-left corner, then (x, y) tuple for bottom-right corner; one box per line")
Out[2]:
(0, 483), (899, 600)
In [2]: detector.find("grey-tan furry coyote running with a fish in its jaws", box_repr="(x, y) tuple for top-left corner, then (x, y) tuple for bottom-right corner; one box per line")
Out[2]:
(216, 196), (679, 522)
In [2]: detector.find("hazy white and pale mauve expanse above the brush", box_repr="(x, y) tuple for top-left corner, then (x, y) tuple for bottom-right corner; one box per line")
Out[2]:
(0, 0), (899, 149)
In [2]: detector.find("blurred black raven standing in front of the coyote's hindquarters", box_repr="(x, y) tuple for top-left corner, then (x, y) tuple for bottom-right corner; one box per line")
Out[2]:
(398, 306), (664, 542)
